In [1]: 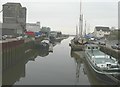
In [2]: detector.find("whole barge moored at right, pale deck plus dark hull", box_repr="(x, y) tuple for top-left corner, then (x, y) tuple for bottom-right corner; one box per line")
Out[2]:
(85, 44), (120, 84)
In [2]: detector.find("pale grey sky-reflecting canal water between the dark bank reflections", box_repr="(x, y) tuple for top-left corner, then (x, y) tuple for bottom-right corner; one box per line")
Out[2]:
(14, 38), (90, 85)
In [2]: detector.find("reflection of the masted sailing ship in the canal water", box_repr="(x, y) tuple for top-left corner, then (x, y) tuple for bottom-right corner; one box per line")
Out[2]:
(71, 50), (90, 85)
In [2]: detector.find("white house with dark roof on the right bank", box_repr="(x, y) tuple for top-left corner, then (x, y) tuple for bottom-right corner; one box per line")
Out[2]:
(94, 27), (110, 38)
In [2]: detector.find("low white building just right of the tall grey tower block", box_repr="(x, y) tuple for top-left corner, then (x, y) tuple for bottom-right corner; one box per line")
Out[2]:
(26, 22), (40, 32)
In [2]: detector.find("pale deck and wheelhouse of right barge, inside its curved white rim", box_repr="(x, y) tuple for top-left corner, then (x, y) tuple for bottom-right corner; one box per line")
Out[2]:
(85, 44), (120, 70)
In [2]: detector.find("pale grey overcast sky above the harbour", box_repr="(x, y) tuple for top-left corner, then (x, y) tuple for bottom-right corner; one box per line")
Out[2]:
(0, 0), (119, 34)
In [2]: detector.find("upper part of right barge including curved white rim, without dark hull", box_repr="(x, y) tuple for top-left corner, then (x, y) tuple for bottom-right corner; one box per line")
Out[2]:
(85, 44), (120, 74)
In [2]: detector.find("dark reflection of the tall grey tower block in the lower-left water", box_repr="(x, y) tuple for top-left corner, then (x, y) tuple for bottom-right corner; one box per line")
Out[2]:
(2, 56), (26, 85)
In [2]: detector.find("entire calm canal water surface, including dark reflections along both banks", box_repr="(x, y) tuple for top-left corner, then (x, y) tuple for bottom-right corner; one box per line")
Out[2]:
(3, 37), (119, 85)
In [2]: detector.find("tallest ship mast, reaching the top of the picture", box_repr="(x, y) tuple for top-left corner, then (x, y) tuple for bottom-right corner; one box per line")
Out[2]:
(79, 0), (83, 37)
